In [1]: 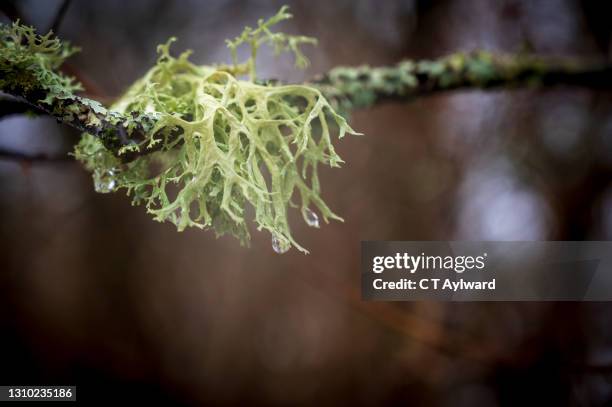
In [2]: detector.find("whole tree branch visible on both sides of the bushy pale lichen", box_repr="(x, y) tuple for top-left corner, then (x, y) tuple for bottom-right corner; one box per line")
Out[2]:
(0, 51), (612, 161)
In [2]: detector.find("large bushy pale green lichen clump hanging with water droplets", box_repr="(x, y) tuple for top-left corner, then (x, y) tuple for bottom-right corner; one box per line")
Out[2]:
(75, 7), (355, 252)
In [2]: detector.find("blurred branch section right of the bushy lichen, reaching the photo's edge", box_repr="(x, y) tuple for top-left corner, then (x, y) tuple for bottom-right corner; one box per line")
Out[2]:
(313, 51), (612, 109)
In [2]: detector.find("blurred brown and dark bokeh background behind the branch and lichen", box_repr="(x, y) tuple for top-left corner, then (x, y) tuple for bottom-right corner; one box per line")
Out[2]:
(0, 0), (612, 406)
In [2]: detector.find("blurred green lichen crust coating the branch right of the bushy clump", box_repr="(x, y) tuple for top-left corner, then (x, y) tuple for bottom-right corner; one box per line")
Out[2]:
(316, 51), (524, 112)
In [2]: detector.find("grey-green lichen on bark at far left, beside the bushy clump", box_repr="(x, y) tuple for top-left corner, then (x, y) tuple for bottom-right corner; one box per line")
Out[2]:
(0, 22), (156, 159)
